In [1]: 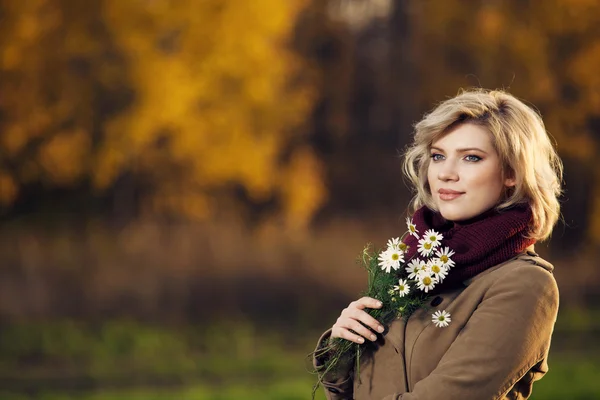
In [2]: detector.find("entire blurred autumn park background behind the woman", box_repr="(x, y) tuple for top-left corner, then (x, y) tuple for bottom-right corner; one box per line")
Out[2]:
(0, 0), (600, 400)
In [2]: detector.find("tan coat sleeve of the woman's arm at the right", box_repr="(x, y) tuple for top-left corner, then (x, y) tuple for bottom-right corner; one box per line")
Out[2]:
(384, 262), (558, 400)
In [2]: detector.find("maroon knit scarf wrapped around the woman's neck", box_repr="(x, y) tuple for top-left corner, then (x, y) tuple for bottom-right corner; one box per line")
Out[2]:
(404, 204), (535, 293)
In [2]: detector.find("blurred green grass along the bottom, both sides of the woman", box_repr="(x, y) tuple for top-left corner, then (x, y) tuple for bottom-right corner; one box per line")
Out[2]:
(0, 321), (600, 400)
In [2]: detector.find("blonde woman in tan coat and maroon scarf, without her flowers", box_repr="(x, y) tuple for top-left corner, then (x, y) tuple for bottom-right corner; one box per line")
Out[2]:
(314, 89), (562, 400)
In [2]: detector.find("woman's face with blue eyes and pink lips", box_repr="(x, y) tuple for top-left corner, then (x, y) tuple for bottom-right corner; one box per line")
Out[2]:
(427, 123), (515, 221)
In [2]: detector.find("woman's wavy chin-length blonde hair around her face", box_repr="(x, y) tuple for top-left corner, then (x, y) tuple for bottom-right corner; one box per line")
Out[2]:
(403, 89), (563, 241)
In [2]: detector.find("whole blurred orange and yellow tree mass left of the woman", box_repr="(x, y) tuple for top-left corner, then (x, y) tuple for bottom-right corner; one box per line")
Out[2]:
(0, 0), (325, 227)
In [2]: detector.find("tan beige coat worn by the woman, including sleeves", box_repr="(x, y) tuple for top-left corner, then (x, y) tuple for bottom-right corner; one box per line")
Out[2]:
(315, 252), (558, 400)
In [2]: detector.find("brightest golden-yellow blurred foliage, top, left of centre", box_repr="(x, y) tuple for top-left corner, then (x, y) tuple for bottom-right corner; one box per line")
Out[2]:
(94, 0), (322, 225)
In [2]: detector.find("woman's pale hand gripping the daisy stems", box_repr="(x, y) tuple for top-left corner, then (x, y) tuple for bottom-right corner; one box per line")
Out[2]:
(331, 297), (383, 343)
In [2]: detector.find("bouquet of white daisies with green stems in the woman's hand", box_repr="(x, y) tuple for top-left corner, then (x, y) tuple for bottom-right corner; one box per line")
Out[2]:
(311, 218), (454, 398)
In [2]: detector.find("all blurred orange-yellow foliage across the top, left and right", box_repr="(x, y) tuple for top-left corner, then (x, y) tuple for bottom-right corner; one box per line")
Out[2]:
(0, 0), (600, 236)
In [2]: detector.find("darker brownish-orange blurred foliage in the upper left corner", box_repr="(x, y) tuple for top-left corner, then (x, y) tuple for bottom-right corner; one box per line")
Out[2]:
(0, 0), (92, 191)
